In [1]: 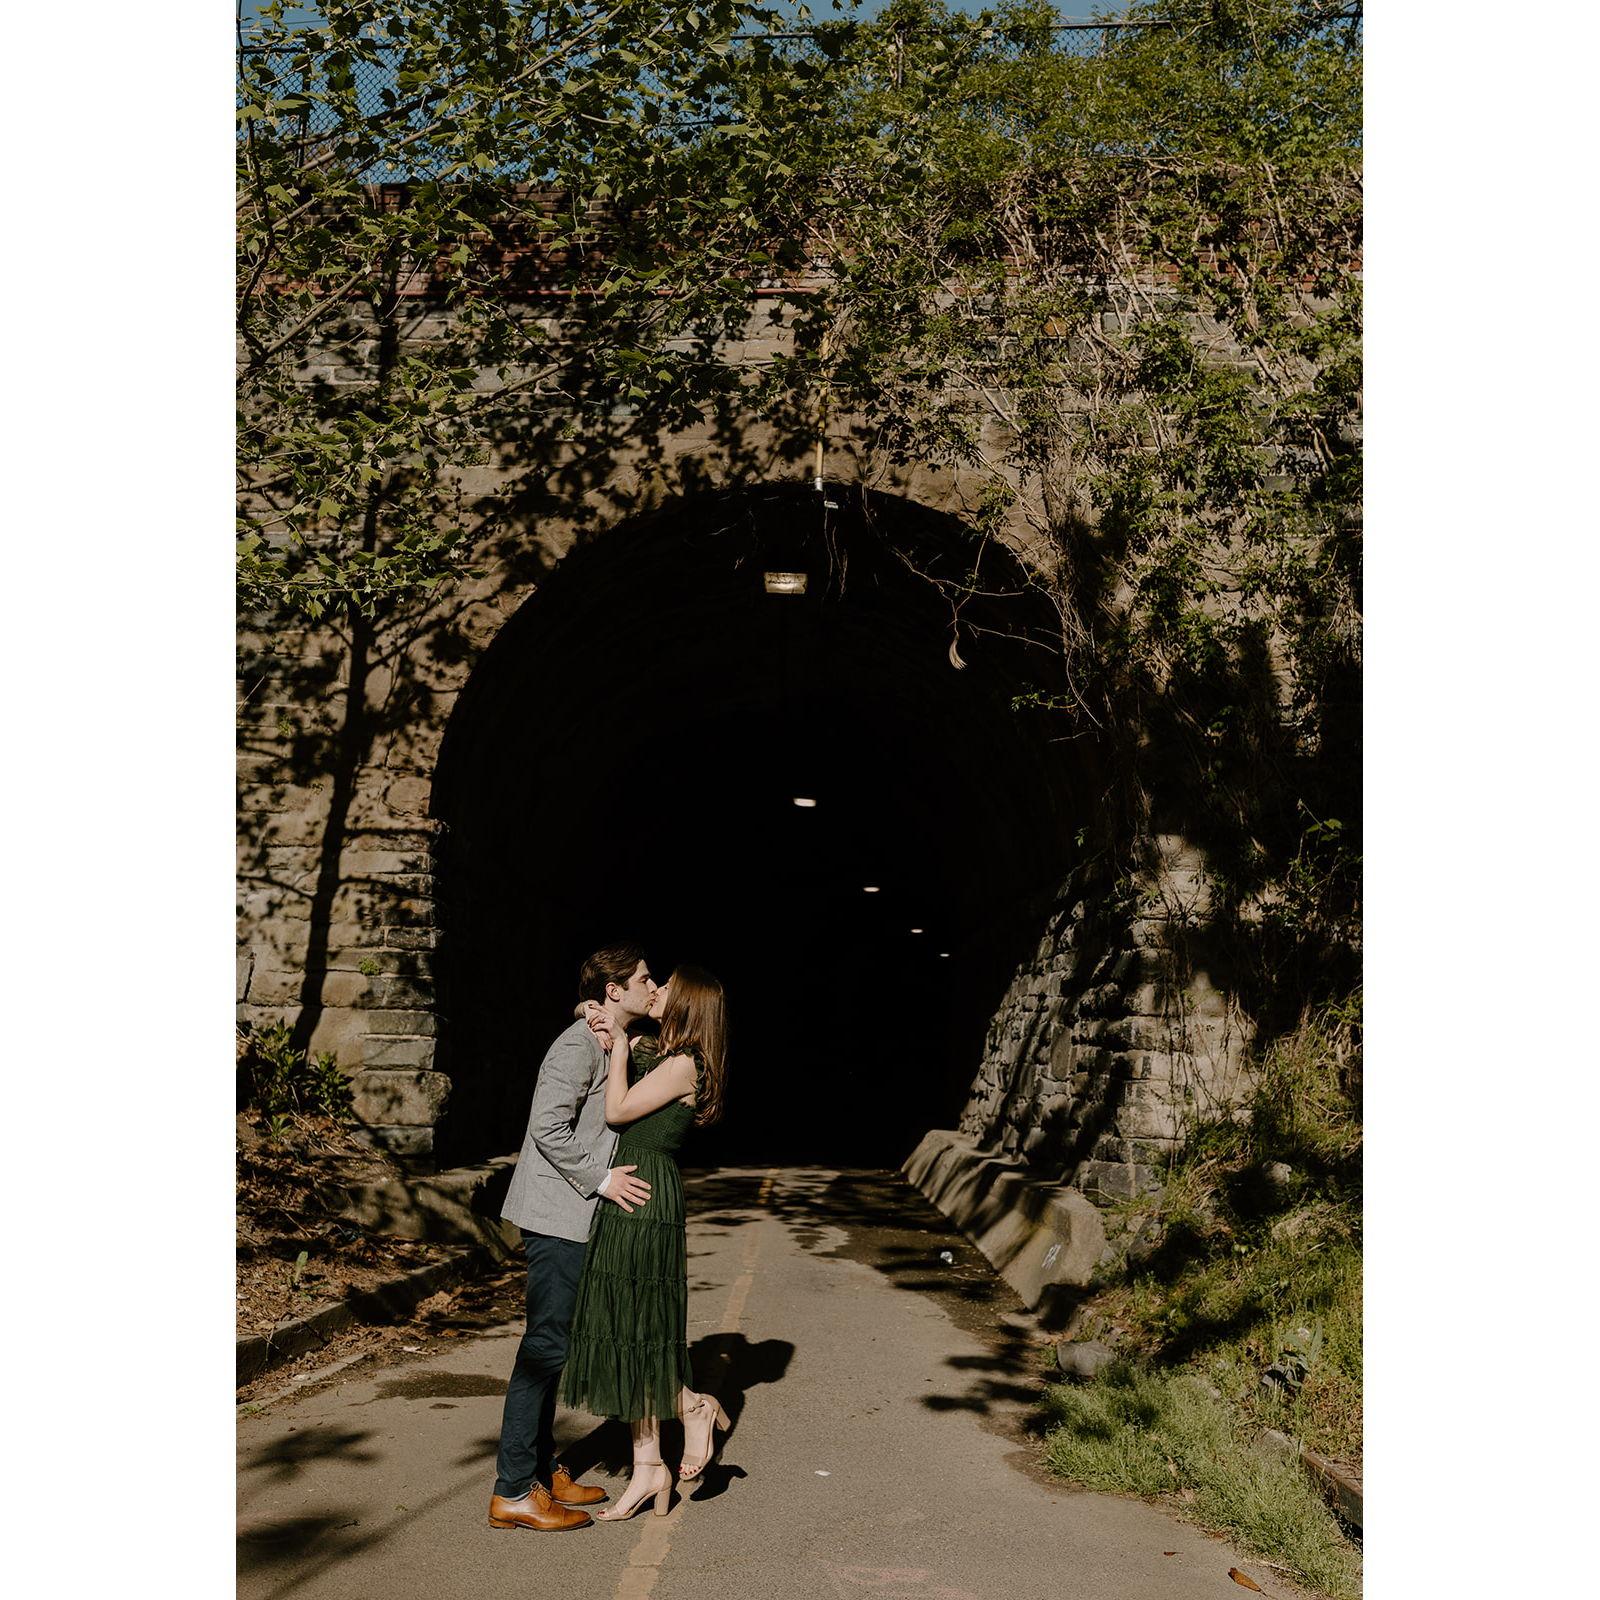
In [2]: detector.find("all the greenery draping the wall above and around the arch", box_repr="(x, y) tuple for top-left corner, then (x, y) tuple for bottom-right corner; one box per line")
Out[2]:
(238, 0), (1362, 998)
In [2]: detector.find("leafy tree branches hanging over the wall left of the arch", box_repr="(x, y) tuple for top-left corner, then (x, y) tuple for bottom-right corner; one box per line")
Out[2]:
(237, 0), (812, 622)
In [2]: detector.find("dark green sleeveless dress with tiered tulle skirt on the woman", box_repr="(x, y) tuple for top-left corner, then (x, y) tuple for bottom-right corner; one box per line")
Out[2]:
(562, 1040), (699, 1421)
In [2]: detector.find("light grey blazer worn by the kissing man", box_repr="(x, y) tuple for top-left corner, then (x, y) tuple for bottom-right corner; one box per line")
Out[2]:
(501, 1018), (616, 1243)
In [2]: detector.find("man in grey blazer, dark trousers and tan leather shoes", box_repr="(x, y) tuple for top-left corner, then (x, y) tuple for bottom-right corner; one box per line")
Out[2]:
(490, 944), (656, 1533)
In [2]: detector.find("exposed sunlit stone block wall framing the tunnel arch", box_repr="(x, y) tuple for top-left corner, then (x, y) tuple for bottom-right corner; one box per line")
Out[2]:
(235, 302), (1273, 1171)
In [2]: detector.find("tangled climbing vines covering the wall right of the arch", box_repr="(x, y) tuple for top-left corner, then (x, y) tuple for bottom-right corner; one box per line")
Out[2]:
(733, 0), (1362, 998)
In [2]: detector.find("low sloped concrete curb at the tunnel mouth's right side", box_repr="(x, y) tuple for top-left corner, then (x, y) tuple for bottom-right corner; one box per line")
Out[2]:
(901, 1128), (1106, 1325)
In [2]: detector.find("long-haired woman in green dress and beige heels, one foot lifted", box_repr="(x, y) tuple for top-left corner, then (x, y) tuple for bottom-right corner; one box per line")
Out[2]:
(562, 966), (728, 1522)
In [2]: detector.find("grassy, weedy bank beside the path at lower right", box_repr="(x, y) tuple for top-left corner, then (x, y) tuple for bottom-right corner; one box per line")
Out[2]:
(1048, 994), (1362, 1597)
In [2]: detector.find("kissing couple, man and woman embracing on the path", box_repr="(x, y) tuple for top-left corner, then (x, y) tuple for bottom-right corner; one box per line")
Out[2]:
(490, 944), (728, 1533)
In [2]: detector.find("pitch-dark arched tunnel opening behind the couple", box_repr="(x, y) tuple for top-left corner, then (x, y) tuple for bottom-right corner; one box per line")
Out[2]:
(434, 488), (1074, 1166)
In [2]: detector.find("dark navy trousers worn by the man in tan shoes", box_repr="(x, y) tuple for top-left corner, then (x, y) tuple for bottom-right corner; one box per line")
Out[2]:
(494, 1229), (586, 1499)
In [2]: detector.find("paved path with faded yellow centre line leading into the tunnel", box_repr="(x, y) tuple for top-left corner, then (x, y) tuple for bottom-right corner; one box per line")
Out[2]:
(238, 1168), (1294, 1600)
